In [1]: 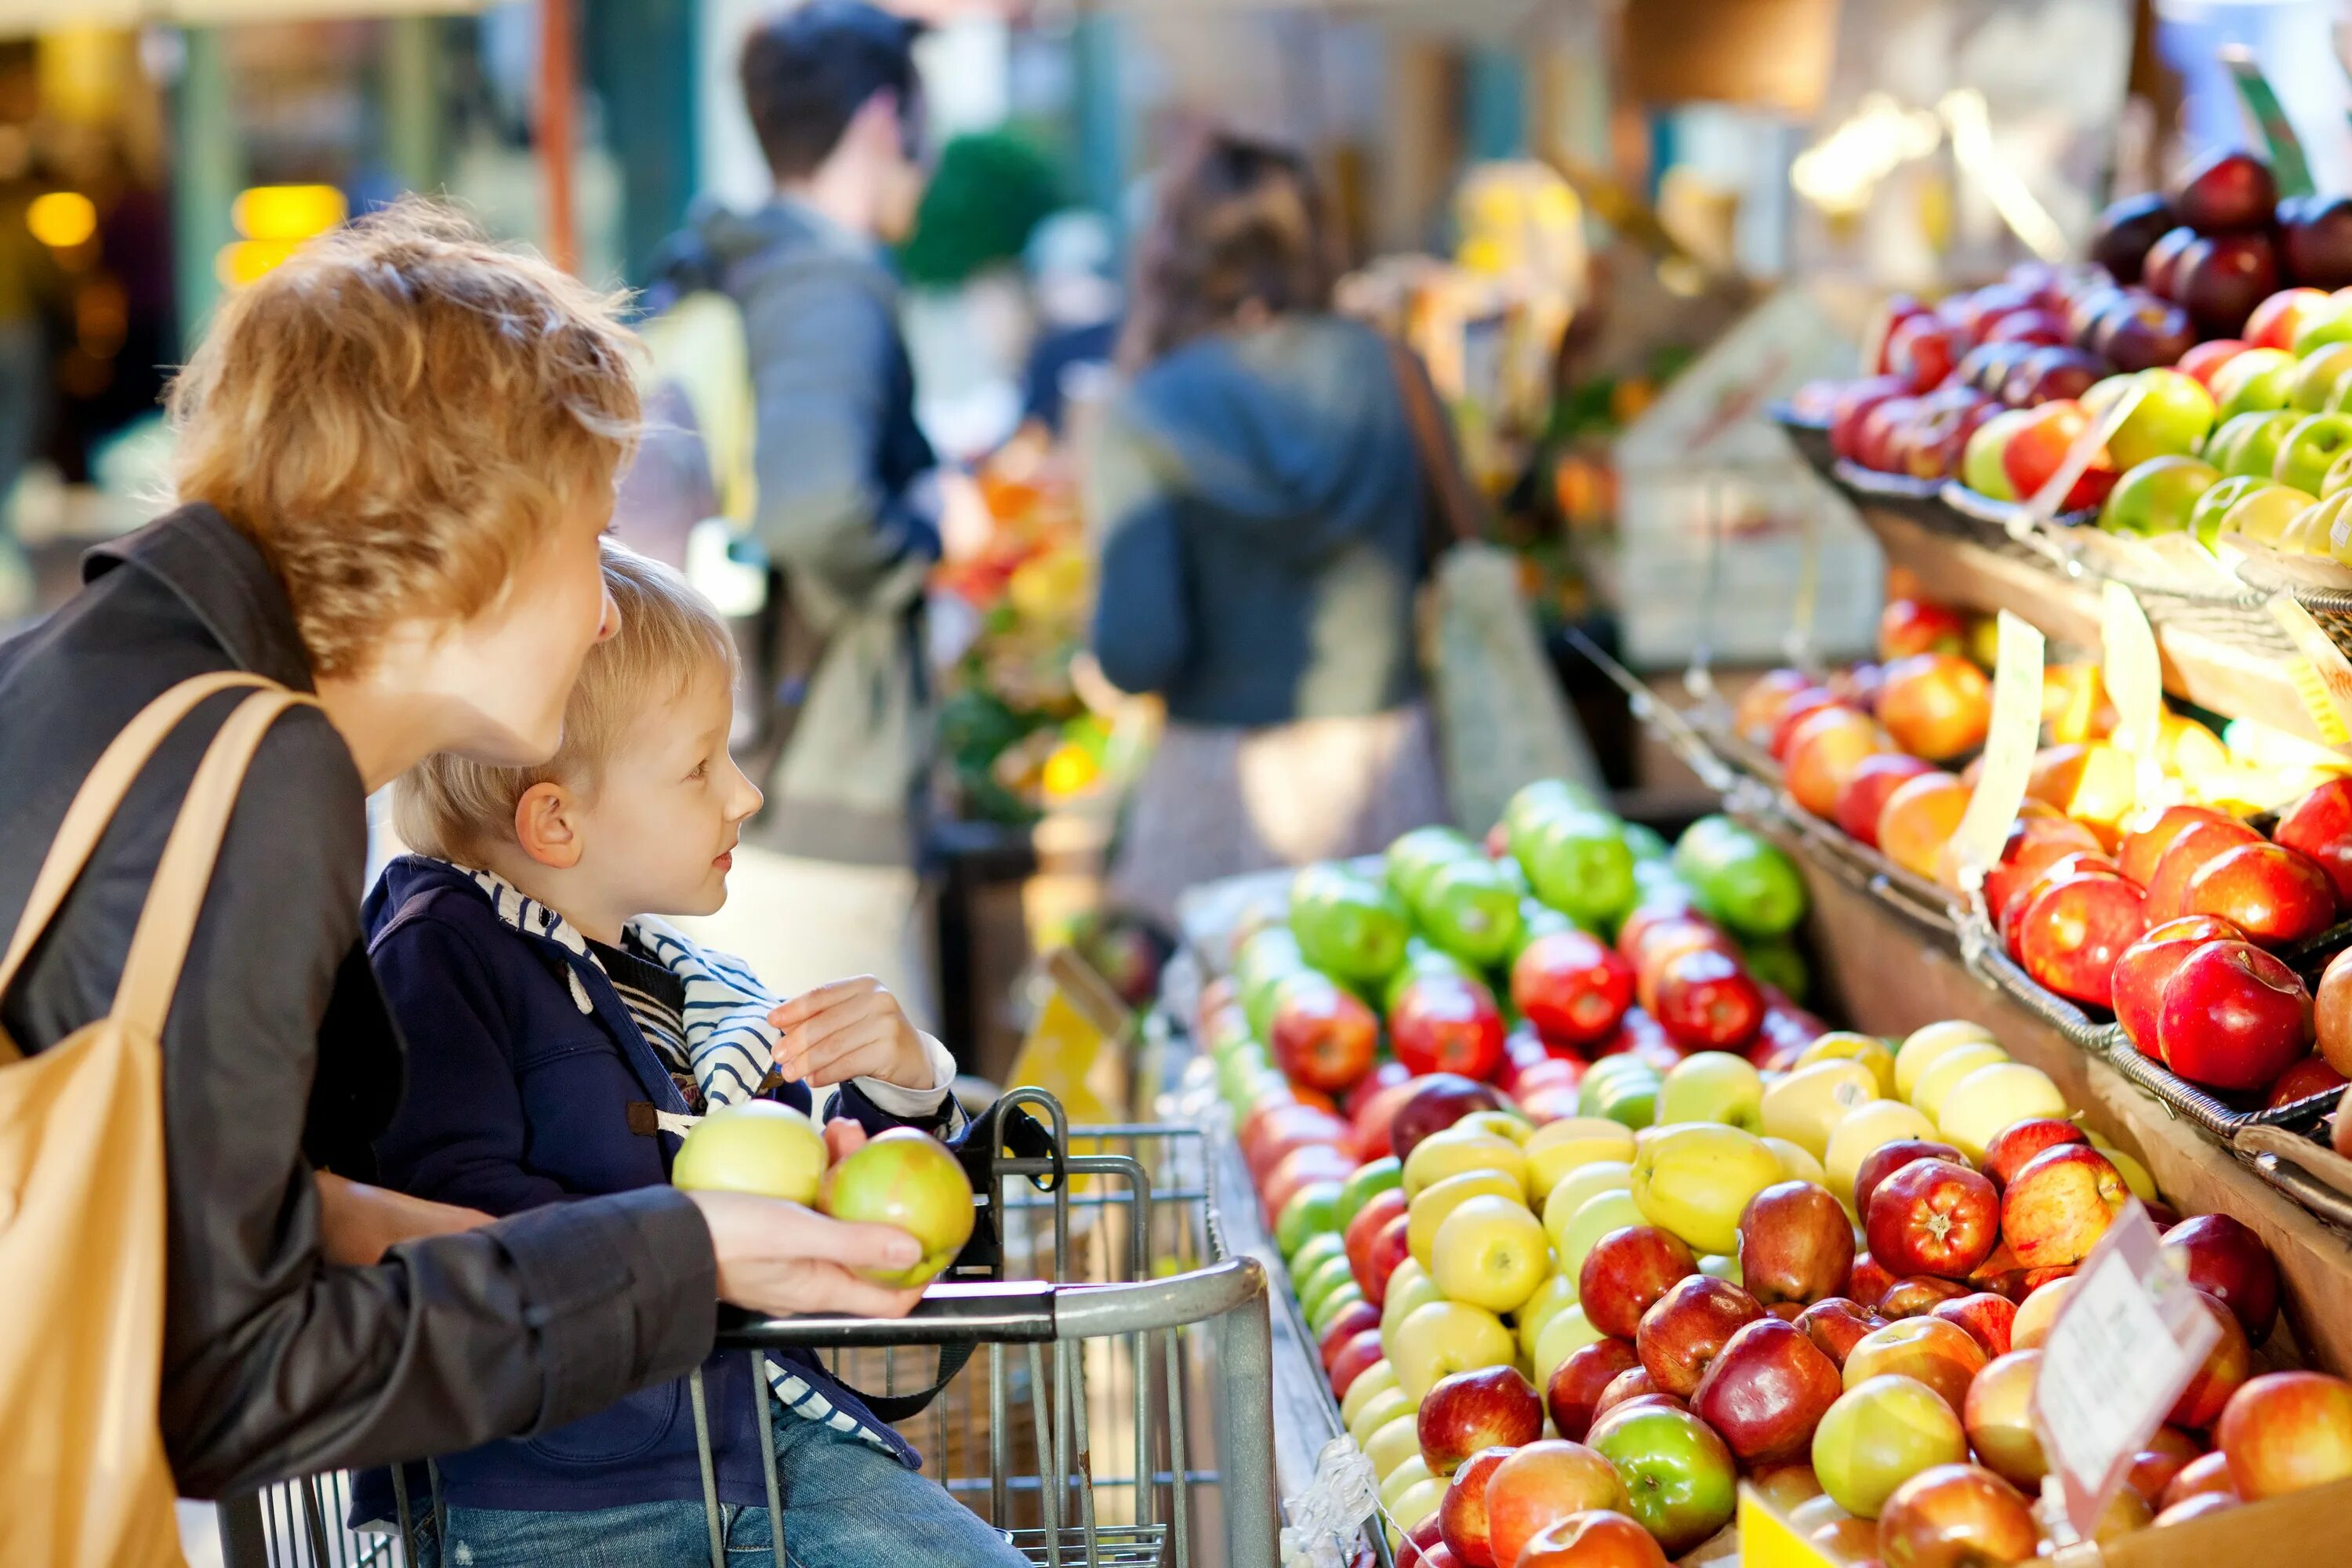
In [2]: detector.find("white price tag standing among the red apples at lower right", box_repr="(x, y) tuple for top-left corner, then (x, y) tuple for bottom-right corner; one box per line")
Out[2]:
(2034, 1201), (2220, 1537)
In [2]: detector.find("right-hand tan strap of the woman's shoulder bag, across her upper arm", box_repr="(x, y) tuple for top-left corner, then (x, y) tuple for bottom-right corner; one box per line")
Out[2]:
(111, 687), (318, 1039)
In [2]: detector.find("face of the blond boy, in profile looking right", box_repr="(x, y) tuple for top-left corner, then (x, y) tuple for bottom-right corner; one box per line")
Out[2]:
(574, 670), (760, 919)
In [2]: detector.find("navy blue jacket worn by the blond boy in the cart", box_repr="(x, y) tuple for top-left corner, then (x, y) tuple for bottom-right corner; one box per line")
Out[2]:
(353, 855), (950, 1519)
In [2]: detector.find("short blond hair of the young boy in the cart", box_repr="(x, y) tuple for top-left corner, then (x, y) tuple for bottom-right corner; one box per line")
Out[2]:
(393, 543), (736, 862)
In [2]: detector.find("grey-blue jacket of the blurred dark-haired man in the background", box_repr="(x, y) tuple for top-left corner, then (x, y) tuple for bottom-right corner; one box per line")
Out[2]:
(656, 202), (938, 865)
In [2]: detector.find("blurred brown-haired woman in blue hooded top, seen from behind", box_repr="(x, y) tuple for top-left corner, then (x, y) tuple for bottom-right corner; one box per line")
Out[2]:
(1089, 132), (1444, 924)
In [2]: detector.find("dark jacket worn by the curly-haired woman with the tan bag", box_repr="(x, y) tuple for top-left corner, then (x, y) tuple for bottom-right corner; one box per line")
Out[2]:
(0, 506), (717, 1497)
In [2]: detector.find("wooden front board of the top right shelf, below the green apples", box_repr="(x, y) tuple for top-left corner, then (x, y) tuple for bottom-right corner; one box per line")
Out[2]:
(1858, 506), (2326, 746)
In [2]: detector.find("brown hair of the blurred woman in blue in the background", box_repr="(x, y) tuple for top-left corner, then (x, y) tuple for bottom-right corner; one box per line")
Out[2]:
(1120, 132), (1338, 369)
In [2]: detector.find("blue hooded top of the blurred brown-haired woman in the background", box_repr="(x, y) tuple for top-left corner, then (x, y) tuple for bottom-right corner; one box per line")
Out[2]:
(1087, 315), (1428, 727)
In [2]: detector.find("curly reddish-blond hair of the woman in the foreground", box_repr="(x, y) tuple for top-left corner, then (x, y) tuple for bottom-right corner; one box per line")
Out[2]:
(167, 198), (640, 675)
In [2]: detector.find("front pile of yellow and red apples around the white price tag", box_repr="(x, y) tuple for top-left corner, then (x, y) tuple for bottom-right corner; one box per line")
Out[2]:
(1277, 1022), (2314, 1568)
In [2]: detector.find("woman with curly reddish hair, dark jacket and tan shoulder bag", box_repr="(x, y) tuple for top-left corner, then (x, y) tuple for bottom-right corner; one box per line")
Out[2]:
(0, 205), (917, 1568)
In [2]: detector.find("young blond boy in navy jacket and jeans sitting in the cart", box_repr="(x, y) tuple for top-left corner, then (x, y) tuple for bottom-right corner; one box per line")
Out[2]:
(355, 548), (1021, 1568)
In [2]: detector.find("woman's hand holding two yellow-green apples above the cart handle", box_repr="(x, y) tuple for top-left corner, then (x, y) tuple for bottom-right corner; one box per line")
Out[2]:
(687, 1192), (922, 1316)
